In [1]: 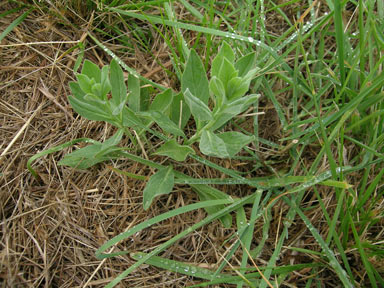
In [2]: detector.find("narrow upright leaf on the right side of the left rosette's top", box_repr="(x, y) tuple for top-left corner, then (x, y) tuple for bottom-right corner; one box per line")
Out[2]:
(110, 60), (127, 107)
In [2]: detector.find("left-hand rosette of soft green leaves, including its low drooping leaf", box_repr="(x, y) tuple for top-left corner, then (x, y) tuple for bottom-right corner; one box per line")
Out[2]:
(59, 60), (180, 169)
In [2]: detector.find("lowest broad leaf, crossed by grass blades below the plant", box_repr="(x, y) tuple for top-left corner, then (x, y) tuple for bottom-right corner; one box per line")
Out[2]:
(191, 184), (232, 228)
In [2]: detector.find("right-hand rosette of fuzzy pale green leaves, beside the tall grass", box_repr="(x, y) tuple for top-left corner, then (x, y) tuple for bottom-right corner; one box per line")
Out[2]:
(164, 42), (259, 158)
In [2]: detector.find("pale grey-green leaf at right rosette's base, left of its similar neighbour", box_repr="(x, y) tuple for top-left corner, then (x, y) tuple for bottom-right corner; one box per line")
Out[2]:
(199, 130), (229, 158)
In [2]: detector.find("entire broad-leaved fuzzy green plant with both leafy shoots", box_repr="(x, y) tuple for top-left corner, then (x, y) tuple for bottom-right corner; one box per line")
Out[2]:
(59, 42), (259, 209)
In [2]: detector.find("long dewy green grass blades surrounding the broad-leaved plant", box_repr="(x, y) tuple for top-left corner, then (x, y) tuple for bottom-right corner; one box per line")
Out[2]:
(21, 0), (384, 287)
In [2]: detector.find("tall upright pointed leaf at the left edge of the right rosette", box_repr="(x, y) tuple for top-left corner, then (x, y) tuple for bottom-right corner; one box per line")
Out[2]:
(181, 49), (209, 104)
